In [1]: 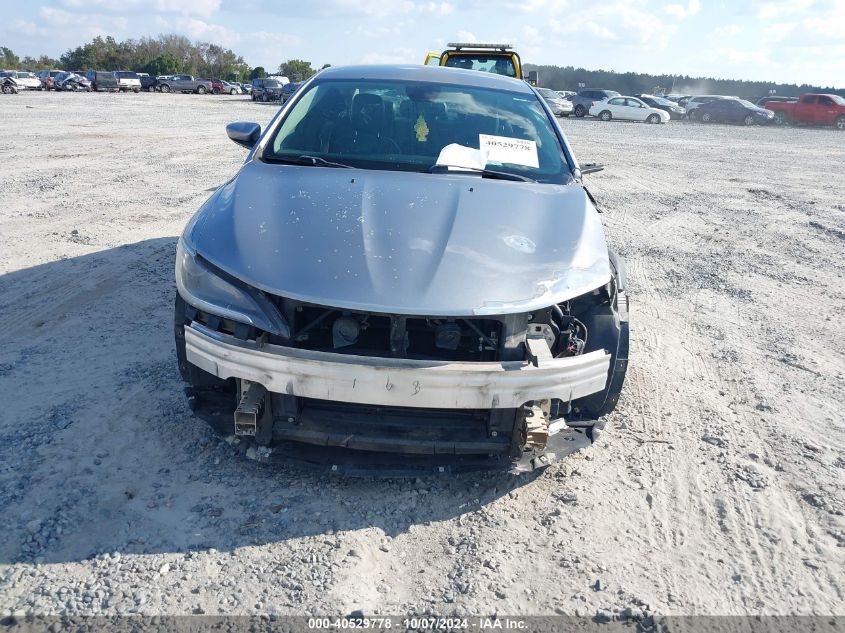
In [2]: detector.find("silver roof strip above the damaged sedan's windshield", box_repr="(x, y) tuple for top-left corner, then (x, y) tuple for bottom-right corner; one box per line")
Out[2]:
(319, 64), (532, 94)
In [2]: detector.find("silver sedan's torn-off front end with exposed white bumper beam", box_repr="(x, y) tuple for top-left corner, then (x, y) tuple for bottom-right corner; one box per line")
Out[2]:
(175, 248), (628, 476)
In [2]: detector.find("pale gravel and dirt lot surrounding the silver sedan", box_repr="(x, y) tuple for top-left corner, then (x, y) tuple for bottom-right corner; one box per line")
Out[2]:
(0, 93), (845, 618)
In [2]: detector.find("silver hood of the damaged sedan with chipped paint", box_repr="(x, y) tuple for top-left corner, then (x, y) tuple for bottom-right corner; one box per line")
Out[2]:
(183, 161), (610, 316)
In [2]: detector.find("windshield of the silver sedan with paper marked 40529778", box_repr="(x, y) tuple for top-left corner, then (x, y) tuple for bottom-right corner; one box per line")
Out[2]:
(264, 80), (571, 183)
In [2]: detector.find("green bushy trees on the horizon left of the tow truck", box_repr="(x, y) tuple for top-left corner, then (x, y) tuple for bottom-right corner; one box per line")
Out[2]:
(0, 34), (328, 81)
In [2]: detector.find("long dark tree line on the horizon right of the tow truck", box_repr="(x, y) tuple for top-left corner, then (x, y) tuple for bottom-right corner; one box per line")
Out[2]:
(525, 64), (845, 99)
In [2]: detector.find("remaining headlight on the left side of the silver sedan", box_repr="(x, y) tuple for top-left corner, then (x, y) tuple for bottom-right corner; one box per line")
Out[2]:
(176, 238), (290, 338)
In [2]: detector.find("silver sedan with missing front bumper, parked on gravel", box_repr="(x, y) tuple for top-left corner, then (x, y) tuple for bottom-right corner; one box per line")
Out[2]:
(175, 65), (628, 476)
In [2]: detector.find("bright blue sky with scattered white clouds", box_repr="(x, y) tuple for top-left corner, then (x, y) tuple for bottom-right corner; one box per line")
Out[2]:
(0, 0), (845, 87)
